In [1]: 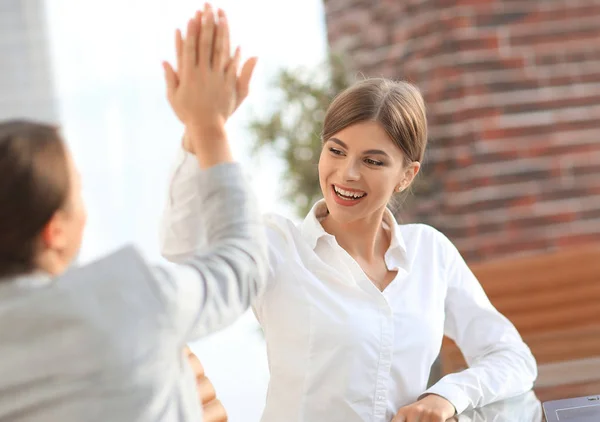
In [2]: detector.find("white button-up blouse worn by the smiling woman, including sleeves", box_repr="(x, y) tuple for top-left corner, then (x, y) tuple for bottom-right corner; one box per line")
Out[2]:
(161, 148), (537, 422)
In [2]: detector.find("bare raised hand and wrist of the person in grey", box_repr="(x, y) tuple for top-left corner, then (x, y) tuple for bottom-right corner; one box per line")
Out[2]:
(163, 5), (240, 167)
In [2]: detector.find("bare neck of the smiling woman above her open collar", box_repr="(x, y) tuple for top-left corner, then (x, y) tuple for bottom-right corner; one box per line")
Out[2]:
(322, 208), (389, 261)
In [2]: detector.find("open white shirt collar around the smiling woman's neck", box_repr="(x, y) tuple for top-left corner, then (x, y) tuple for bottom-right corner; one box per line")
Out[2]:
(300, 199), (409, 271)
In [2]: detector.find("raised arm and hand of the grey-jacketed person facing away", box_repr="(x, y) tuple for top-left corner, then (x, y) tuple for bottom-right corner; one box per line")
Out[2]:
(155, 7), (267, 341)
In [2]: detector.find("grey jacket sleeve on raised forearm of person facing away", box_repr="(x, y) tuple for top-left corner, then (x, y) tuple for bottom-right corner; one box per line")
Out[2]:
(186, 164), (267, 337)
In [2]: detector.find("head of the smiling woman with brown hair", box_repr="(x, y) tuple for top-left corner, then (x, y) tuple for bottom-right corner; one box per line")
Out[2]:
(319, 79), (427, 223)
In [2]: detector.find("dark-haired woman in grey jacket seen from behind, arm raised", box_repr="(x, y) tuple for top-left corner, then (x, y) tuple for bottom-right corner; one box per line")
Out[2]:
(0, 9), (266, 422)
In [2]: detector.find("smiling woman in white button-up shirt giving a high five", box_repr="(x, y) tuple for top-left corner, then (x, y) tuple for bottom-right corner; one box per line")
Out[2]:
(162, 79), (536, 422)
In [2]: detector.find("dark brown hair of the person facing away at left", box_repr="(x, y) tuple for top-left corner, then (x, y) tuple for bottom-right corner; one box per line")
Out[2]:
(0, 120), (69, 277)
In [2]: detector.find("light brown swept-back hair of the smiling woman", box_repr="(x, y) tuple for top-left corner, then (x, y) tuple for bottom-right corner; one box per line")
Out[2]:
(321, 78), (427, 163)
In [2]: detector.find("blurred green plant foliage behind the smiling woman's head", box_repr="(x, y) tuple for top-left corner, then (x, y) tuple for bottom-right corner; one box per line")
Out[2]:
(249, 55), (351, 218)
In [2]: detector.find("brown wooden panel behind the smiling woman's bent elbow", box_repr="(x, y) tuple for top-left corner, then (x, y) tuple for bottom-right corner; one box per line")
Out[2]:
(441, 245), (600, 374)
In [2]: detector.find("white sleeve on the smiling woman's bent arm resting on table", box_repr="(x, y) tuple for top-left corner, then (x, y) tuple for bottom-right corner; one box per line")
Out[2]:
(426, 235), (537, 413)
